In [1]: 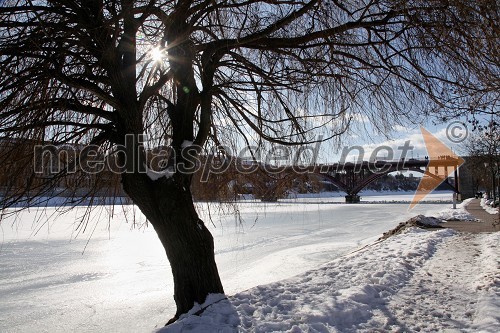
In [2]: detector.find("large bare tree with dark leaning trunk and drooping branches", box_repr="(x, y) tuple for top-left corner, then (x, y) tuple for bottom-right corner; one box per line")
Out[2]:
(0, 0), (500, 319)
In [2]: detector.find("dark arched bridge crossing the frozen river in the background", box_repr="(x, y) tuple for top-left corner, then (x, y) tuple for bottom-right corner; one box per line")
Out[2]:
(226, 156), (460, 203)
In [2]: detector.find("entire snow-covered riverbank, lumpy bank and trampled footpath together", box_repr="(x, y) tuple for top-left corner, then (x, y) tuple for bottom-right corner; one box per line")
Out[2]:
(161, 228), (500, 333)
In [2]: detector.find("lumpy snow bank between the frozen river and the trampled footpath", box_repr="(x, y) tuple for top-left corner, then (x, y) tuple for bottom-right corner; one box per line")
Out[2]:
(159, 228), (455, 333)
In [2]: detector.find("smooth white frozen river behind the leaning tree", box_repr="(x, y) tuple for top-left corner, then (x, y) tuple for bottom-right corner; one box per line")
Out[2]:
(0, 194), (451, 332)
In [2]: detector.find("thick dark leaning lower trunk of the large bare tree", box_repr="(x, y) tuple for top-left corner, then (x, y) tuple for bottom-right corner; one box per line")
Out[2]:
(123, 174), (224, 323)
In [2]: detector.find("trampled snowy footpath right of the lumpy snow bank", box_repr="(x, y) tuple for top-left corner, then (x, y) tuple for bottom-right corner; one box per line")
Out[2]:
(388, 233), (500, 332)
